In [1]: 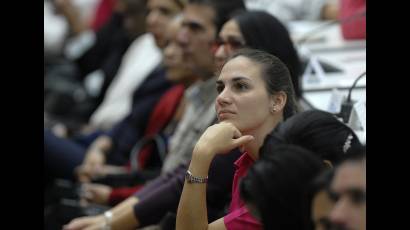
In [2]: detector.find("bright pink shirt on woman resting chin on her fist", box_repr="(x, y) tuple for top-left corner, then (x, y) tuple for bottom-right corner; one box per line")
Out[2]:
(224, 152), (262, 230)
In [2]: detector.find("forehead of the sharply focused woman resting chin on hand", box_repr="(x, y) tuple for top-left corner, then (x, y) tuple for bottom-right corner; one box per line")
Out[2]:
(218, 56), (262, 81)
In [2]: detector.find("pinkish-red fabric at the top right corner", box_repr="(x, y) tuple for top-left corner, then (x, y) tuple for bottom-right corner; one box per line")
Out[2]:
(340, 0), (366, 40)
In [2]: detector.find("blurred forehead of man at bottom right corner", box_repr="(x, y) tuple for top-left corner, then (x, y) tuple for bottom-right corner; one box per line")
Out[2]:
(331, 162), (366, 192)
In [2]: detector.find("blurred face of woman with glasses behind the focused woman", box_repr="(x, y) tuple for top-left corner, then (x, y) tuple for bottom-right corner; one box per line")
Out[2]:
(215, 19), (246, 73)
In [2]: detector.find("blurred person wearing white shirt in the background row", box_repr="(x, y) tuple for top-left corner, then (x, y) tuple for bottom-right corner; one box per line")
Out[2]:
(90, 0), (185, 130)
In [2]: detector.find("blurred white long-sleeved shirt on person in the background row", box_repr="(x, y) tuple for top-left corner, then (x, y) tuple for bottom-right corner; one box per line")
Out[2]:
(90, 33), (162, 129)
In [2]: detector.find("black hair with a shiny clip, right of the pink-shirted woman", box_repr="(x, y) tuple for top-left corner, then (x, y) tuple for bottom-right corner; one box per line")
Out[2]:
(260, 110), (364, 165)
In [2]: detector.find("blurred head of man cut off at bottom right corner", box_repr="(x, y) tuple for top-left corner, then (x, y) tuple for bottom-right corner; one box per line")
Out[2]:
(329, 151), (366, 230)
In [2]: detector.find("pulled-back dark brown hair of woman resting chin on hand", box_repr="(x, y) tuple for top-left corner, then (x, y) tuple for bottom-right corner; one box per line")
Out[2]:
(228, 48), (298, 119)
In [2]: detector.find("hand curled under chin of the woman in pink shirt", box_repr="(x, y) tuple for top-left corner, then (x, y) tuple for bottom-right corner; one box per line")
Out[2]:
(194, 122), (254, 156)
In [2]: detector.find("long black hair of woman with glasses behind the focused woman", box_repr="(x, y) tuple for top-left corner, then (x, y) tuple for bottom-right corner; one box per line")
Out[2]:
(232, 11), (302, 98)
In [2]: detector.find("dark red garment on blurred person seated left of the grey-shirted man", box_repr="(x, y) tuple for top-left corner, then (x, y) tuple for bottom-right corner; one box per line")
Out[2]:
(109, 85), (185, 203)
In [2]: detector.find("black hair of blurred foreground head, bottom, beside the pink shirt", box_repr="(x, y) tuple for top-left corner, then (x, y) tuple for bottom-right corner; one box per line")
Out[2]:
(240, 144), (323, 230)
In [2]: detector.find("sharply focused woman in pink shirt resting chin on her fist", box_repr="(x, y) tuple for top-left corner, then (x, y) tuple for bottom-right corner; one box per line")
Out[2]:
(176, 49), (295, 229)
